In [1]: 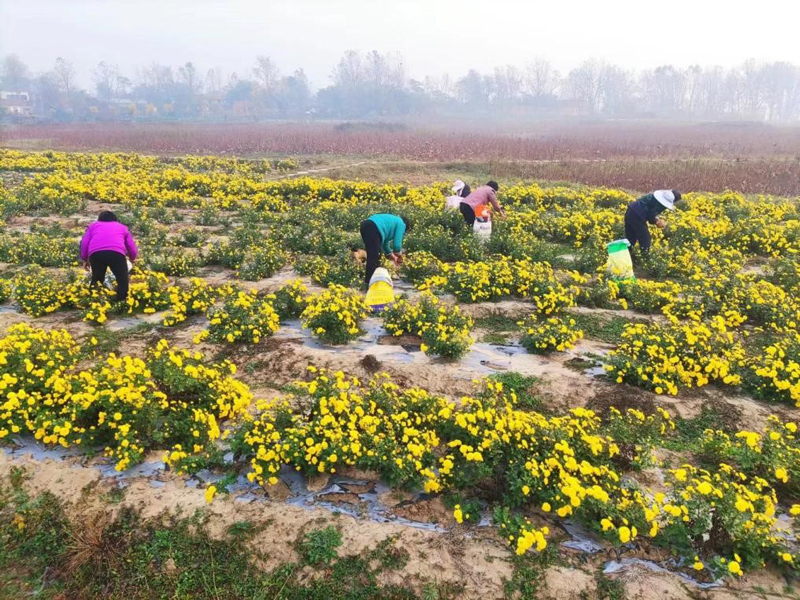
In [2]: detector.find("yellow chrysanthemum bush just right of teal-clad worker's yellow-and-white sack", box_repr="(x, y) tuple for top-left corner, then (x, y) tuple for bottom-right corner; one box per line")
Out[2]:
(382, 292), (473, 359)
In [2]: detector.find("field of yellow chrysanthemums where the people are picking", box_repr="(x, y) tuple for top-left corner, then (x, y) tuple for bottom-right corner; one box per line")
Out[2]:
(0, 150), (800, 583)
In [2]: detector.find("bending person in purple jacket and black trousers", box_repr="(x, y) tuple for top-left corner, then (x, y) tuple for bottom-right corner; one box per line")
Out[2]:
(81, 210), (139, 301)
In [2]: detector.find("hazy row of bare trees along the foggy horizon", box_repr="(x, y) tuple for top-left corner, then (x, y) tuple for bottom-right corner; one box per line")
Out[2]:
(0, 50), (800, 122)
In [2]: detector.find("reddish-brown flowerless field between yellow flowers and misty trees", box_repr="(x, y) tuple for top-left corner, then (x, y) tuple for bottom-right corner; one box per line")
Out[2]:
(0, 122), (800, 195)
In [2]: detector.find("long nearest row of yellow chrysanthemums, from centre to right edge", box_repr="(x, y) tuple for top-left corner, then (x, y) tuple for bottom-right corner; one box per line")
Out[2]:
(236, 368), (797, 578)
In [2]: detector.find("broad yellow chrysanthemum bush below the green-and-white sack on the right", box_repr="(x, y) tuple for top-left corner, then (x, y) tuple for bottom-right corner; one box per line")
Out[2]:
(606, 317), (745, 395)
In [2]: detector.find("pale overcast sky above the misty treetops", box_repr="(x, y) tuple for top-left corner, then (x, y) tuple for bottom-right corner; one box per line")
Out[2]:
(0, 0), (800, 87)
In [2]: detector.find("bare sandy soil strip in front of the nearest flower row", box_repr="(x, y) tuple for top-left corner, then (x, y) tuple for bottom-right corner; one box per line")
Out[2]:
(0, 448), (797, 600)
